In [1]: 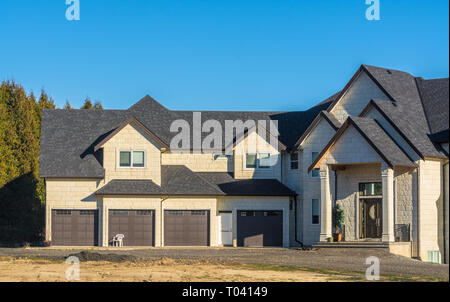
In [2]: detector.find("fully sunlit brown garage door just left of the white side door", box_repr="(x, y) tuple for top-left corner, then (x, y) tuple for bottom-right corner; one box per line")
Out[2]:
(164, 210), (209, 246)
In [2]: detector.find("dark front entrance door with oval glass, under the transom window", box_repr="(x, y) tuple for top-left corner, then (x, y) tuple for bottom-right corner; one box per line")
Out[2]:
(360, 198), (381, 238)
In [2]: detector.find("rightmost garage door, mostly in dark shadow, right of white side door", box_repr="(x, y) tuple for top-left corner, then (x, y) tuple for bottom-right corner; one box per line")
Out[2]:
(237, 211), (283, 247)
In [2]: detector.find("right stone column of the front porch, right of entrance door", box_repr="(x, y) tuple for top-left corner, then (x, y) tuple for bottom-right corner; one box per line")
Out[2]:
(381, 165), (395, 242)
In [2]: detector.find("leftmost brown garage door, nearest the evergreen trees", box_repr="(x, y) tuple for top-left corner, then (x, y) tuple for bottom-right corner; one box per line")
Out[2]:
(52, 210), (98, 246)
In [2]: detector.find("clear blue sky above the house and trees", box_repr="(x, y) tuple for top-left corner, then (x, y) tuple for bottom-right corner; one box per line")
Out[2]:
(0, 0), (449, 111)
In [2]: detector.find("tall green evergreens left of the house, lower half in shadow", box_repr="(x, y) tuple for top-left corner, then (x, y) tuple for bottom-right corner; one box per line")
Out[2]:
(0, 81), (49, 243)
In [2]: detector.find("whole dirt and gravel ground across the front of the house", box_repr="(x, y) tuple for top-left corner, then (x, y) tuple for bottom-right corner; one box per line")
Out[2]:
(0, 248), (449, 281)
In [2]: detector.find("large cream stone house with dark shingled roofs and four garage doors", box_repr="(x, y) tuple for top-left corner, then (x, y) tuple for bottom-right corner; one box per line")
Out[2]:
(40, 65), (449, 263)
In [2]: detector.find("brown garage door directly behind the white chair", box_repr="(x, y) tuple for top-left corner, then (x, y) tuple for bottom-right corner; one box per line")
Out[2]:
(108, 210), (155, 246)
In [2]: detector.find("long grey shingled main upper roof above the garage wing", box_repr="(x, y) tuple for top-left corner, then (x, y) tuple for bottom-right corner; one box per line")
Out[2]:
(39, 92), (338, 178)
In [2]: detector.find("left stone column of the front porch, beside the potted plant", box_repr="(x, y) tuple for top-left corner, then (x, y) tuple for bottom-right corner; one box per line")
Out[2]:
(320, 165), (332, 241)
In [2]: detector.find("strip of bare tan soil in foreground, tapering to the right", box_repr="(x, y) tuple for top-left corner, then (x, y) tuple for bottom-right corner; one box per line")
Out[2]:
(0, 257), (354, 282)
